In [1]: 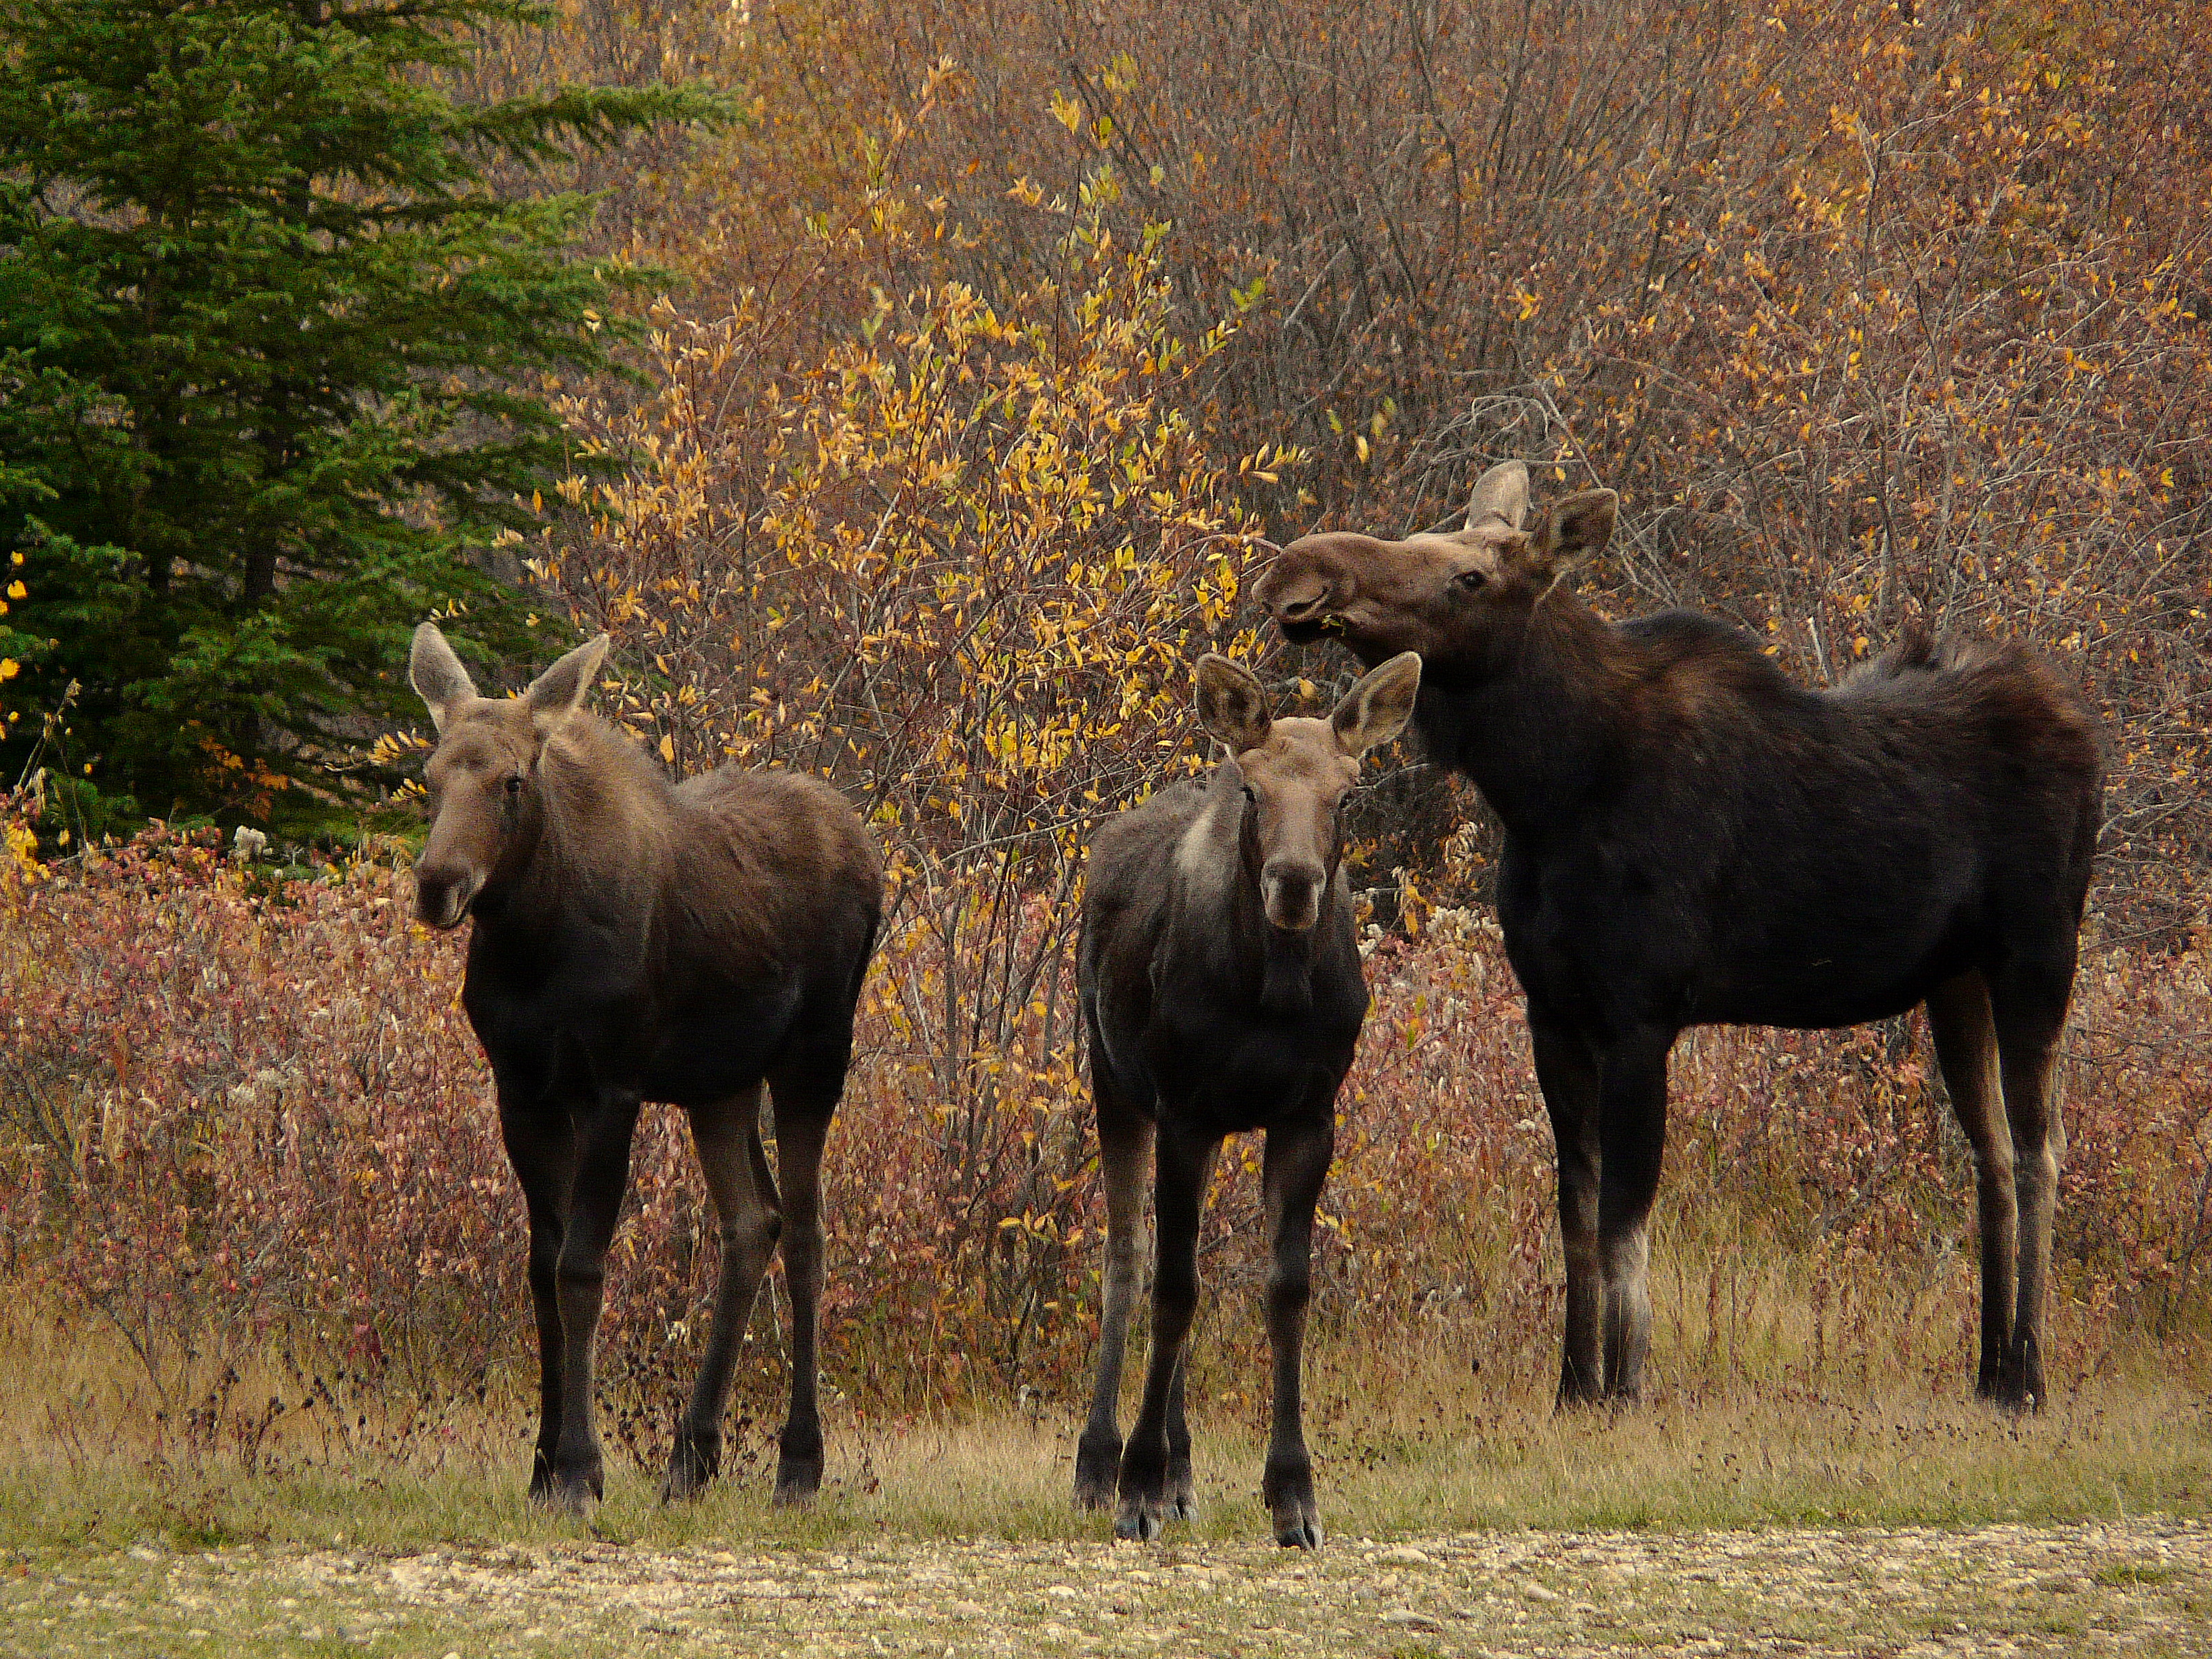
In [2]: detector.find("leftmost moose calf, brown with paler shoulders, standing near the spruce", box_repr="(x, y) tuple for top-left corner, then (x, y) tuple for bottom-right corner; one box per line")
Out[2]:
(409, 621), (882, 1509)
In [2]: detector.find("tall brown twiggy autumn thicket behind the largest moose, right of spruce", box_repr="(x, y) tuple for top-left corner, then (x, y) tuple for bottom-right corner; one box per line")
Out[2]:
(457, 0), (2212, 931)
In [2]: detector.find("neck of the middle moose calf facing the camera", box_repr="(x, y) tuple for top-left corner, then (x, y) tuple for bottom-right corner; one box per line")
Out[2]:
(1168, 761), (1336, 1017)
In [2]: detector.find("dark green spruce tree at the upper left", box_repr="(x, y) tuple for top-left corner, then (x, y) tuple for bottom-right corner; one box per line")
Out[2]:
(0, 0), (730, 832)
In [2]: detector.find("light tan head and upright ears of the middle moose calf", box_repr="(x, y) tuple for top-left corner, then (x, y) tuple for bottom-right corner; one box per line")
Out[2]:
(1186, 653), (1420, 933)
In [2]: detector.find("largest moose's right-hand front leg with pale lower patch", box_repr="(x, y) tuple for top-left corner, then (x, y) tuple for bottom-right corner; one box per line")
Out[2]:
(1597, 1031), (1675, 1400)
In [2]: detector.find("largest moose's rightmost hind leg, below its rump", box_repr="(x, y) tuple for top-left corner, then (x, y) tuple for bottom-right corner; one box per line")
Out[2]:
(1988, 946), (2075, 1411)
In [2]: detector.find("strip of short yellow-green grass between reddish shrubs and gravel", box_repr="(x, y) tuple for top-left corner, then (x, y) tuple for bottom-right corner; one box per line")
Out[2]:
(13, 1382), (2212, 1549)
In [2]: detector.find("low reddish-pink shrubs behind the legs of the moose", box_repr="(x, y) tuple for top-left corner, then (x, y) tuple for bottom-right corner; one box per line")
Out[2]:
(0, 814), (2212, 1456)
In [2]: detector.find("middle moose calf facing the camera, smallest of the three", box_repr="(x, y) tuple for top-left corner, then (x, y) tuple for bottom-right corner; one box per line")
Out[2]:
(1075, 655), (1420, 1549)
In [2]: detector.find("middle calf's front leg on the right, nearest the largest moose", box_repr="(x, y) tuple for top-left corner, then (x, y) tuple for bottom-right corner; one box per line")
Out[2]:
(1261, 1104), (1336, 1551)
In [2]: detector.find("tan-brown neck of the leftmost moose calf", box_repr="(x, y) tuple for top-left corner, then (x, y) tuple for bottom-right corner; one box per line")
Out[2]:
(473, 714), (670, 949)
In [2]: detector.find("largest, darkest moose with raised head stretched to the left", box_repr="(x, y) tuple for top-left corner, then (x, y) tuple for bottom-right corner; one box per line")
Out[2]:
(1256, 462), (2104, 1407)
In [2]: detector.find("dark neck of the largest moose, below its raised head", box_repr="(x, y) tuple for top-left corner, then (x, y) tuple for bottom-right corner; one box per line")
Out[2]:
(1414, 586), (1633, 840)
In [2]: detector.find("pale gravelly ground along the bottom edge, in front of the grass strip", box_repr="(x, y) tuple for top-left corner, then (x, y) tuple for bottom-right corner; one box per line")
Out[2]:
(0, 1519), (2212, 1659)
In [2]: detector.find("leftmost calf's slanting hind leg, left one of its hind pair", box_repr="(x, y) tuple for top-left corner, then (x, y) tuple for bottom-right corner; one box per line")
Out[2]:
(661, 1086), (781, 1502)
